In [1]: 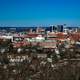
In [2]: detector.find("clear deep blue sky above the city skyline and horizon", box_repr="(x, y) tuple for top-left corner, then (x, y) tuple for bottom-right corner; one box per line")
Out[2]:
(0, 0), (80, 26)
